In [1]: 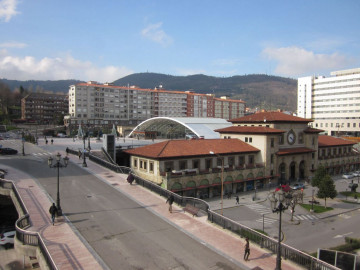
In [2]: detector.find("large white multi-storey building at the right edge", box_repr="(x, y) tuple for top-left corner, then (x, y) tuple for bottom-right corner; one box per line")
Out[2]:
(297, 68), (360, 136)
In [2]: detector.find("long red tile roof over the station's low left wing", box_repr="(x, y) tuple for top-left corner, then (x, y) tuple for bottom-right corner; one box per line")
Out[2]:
(125, 139), (260, 159)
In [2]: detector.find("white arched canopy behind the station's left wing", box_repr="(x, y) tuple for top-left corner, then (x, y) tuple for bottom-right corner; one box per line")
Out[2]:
(129, 117), (231, 139)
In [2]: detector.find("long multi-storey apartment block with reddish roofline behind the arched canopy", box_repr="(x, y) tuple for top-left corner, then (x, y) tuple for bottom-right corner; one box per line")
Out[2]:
(65, 81), (245, 132)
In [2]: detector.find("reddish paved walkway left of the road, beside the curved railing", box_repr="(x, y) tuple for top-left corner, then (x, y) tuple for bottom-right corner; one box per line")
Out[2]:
(1, 165), (104, 270)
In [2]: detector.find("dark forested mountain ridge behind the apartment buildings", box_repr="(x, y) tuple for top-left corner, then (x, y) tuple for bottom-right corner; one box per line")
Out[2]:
(0, 72), (297, 111)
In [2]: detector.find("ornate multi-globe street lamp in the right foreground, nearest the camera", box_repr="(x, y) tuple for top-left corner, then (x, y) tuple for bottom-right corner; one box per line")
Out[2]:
(269, 190), (291, 270)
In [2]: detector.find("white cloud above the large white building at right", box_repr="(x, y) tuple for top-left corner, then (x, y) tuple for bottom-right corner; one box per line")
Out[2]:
(262, 47), (353, 77)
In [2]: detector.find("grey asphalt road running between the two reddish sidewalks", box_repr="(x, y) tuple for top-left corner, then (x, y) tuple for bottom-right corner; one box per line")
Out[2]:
(1, 142), (240, 269)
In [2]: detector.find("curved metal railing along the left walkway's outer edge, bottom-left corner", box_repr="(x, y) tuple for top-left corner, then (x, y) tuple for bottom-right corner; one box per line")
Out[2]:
(0, 179), (58, 270)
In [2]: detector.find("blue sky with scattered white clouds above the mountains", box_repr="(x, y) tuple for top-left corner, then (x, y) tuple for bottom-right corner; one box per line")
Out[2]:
(0, 0), (360, 83)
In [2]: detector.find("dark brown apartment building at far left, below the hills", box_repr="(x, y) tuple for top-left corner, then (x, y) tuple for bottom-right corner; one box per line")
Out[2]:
(21, 93), (69, 124)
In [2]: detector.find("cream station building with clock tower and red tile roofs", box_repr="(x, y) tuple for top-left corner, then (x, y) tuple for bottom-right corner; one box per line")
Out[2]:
(126, 112), (360, 198)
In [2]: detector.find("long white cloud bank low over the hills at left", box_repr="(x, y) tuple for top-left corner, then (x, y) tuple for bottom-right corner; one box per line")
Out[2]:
(0, 51), (133, 82)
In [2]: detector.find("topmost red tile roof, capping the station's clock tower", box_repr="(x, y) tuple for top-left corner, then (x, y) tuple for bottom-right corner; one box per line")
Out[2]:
(229, 112), (313, 123)
